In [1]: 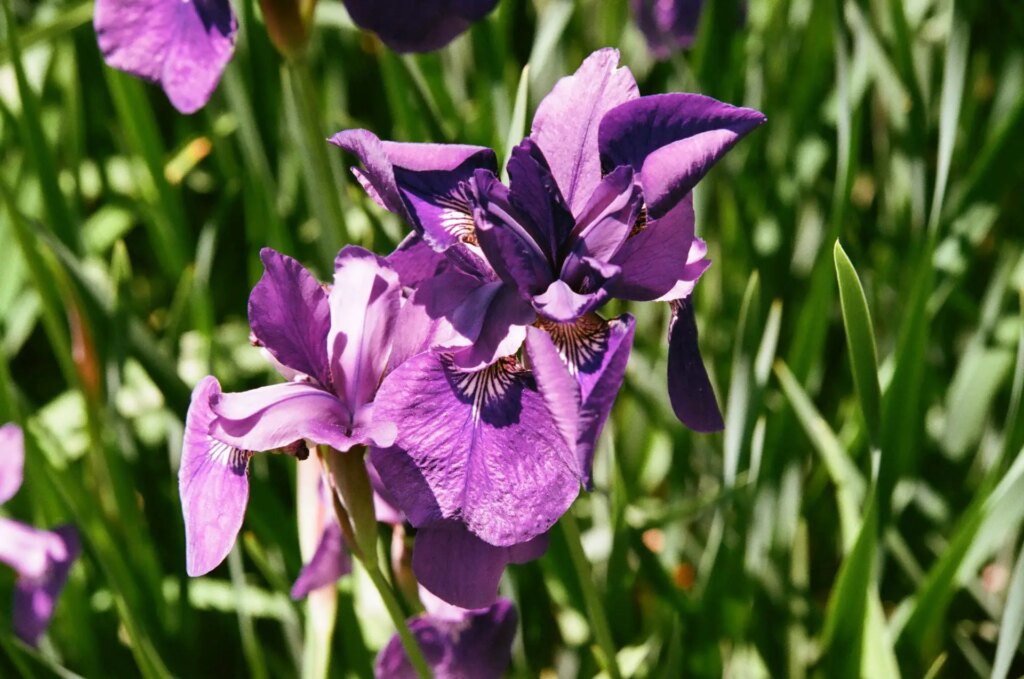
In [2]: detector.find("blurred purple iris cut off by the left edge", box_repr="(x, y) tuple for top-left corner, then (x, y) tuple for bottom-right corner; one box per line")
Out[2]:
(0, 424), (81, 645)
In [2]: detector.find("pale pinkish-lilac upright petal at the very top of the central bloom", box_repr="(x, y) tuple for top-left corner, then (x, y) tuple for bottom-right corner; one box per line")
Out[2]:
(530, 49), (638, 215)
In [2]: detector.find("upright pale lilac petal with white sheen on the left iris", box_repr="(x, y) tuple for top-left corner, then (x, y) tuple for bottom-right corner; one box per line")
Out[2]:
(327, 246), (401, 413)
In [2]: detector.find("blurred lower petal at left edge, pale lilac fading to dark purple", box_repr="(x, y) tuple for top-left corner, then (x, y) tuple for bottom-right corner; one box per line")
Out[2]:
(0, 519), (81, 646)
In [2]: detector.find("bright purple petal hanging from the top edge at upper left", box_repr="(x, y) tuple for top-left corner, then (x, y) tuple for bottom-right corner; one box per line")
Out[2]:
(93, 0), (239, 114)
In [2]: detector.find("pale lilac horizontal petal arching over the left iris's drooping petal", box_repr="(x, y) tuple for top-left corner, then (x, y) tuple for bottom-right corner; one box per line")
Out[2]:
(210, 382), (395, 451)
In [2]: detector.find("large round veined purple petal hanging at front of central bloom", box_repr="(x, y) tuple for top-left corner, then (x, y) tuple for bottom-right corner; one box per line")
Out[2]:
(373, 353), (580, 546)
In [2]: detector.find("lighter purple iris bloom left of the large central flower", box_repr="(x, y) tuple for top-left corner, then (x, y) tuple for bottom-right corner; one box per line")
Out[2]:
(178, 246), (402, 576)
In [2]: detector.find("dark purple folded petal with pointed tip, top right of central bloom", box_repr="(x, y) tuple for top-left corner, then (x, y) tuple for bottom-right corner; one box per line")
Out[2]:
(599, 93), (766, 218)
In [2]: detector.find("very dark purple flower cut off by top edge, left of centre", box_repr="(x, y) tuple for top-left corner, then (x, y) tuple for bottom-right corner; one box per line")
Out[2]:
(344, 0), (498, 52)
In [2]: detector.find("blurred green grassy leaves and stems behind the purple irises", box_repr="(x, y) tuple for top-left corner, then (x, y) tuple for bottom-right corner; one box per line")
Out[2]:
(0, 0), (1024, 678)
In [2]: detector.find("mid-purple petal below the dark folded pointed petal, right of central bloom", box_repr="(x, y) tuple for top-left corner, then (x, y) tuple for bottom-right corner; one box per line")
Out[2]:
(610, 189), (710, 302)
